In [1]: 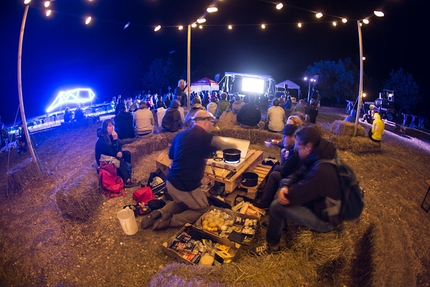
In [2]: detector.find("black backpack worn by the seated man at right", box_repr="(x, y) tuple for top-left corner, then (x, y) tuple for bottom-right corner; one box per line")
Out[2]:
(317, 154), (364, 221)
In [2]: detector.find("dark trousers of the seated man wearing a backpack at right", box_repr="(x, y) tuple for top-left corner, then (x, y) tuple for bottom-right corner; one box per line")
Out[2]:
(266, 199), (334, 245)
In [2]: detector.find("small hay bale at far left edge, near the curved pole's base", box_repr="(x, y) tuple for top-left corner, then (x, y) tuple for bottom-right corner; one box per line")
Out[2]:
(6, 157), (39, 196)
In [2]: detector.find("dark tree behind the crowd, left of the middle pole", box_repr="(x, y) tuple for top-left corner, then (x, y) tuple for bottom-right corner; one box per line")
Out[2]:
(142, 58), (176, 94)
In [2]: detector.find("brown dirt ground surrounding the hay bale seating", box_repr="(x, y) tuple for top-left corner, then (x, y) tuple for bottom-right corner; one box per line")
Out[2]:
(0, 107), (430, 286)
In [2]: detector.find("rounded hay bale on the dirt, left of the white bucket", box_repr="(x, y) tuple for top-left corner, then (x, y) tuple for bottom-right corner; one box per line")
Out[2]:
(55, 169), (104, 221)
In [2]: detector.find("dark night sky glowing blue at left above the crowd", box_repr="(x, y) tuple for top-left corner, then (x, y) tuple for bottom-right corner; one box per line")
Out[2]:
(0, 0), (424, 125)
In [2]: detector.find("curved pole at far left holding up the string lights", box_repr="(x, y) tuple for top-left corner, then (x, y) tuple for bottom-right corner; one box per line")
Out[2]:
(18, 5), (42, 177)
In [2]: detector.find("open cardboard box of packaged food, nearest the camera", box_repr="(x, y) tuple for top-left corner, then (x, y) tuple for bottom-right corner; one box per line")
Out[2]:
(161, 223), (240, 265)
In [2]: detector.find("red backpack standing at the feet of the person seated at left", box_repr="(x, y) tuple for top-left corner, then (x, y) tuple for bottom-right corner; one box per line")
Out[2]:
(99, 162), (125, 197)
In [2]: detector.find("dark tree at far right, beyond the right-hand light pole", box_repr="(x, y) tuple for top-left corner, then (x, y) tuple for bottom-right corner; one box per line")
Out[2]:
(384, 68), (421, 113)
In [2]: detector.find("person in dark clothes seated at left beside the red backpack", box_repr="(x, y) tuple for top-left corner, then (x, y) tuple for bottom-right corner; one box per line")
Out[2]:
(95, 119), (137, 187)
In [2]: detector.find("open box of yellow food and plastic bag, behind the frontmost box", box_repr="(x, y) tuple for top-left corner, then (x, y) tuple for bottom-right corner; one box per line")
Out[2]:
(194, 207), (260, 249)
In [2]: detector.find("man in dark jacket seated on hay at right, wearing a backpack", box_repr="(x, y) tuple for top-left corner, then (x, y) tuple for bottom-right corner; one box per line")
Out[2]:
(249, 125), (341, 256)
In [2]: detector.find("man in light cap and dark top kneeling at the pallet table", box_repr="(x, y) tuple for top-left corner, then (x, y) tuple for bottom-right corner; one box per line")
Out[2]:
(141, 110), (222, 230)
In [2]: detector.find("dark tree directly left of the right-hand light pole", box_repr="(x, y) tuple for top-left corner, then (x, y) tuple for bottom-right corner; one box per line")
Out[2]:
(305, 58), (358, 105)
